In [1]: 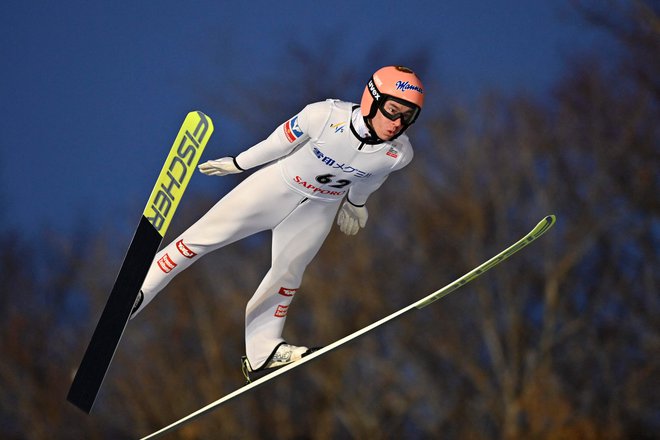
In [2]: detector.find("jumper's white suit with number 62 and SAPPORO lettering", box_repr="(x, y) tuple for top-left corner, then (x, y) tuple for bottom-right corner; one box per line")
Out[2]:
(136, 100), (413, 369)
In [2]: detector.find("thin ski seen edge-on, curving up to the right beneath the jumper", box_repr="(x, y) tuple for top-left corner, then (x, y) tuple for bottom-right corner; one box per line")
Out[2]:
(142, 215), (556, 440)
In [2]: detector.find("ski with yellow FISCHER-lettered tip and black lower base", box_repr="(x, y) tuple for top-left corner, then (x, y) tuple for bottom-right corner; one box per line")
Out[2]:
(67, 111), (213, 413)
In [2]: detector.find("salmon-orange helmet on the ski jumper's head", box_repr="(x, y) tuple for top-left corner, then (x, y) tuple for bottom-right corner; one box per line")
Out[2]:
(360, 66), (424, 126)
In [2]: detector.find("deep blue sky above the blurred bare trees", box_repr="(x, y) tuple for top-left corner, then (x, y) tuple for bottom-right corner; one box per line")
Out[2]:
(0, 0), (592, 234)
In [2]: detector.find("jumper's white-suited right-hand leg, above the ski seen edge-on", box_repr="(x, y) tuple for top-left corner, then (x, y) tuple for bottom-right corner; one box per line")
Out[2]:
(245, 200), (339, 369)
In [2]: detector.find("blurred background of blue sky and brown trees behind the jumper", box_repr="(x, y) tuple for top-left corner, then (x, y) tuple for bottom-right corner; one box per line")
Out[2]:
(0, 0), (660, 439)
